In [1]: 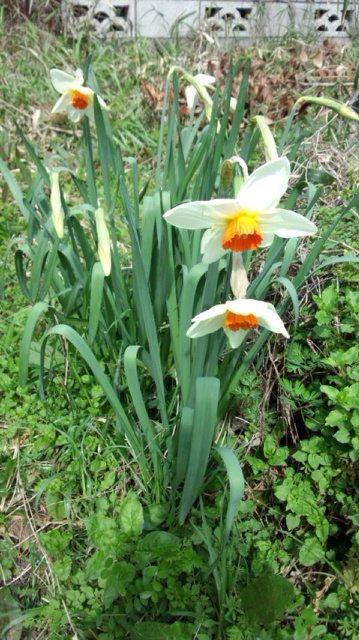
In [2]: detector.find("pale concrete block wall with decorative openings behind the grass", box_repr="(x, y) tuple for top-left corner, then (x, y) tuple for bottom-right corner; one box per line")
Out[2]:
(62, 0), (359, 41)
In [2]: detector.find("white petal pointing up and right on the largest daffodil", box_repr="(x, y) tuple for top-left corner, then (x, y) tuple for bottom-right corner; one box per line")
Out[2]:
(237, 157), (290, 213)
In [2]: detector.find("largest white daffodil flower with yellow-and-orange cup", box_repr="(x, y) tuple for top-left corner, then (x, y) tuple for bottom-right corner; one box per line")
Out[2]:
(164, 157), (317, 263)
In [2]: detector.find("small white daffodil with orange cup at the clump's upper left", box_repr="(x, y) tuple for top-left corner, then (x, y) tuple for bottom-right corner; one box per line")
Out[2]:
(50, 69), (106, 122)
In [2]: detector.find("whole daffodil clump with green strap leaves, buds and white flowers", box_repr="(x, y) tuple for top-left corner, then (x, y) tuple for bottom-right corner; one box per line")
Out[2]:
(0, 62), (358, 536)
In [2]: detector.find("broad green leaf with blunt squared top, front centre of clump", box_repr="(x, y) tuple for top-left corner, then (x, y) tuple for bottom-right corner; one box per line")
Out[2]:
(179, 378), (219, 524)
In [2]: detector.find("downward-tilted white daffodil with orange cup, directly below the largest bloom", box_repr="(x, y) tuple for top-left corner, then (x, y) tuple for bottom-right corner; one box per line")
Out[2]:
(186, 298), (289, 349)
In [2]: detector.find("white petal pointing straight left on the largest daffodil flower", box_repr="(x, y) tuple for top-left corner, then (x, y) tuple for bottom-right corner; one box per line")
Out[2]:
(163, 199), (238, 229)
